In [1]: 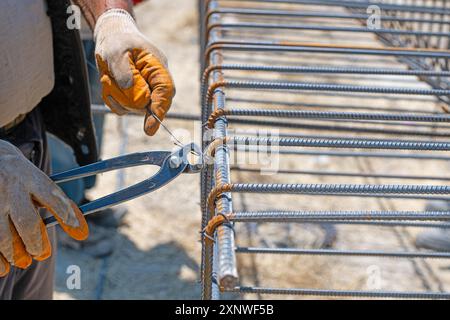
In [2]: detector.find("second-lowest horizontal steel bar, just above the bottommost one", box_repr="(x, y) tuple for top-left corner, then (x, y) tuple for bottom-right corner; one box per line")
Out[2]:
(235, 247), (450, 259)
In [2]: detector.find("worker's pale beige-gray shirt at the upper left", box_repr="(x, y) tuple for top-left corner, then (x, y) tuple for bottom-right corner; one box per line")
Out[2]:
(0, 0), (55, 127)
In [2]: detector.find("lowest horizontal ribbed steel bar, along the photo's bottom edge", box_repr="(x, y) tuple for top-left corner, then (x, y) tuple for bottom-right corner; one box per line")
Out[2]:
(224, 287), (450, 299)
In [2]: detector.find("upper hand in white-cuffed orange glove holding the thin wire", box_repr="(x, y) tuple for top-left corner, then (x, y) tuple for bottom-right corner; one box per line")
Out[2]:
(94, 9), (175, 136)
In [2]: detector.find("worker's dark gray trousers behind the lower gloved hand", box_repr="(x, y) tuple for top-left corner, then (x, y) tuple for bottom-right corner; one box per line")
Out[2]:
(0, 109), (56, 300)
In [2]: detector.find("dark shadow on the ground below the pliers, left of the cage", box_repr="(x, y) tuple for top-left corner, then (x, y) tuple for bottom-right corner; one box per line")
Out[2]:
(55, 226), (200, 299)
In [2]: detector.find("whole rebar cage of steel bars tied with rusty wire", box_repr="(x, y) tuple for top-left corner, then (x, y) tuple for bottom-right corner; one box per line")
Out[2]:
(199, 0), (450, 299)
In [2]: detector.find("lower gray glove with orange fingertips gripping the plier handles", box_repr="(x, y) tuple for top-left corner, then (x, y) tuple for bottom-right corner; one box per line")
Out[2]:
(0, 140), (89, 277)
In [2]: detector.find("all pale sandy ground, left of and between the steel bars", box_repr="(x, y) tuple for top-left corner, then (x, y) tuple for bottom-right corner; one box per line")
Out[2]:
(55, 0), (450, 299)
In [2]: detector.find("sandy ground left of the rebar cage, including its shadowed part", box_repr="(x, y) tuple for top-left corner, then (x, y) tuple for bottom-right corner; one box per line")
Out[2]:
(55, 0), (200, 299)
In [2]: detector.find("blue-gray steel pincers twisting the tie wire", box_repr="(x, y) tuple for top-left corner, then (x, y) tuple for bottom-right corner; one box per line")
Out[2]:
(44, 143), (203, 227)
